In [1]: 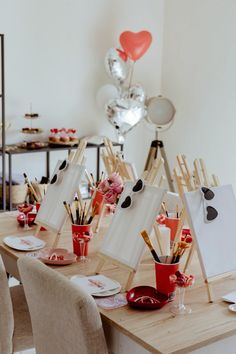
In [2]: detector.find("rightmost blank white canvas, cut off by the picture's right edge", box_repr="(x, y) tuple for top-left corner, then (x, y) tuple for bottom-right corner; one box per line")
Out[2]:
(184, 185), (236, 278)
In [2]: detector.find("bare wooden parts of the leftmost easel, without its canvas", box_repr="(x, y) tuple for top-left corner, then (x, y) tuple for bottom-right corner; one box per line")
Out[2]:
(35, 139), (87, 248)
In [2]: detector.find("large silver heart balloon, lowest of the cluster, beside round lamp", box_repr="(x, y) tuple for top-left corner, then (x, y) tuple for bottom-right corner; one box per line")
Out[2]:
(105, 98), (146, 135)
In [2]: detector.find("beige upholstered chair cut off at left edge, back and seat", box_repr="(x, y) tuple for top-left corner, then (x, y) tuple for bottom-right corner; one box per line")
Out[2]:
(0, 256), (34, 354)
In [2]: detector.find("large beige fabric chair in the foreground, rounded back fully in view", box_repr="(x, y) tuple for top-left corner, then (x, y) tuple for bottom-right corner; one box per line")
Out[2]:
(17, 257), (108, 354)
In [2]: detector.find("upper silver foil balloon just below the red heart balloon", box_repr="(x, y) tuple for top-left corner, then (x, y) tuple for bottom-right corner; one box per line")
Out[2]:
(105, 48), (129, 84)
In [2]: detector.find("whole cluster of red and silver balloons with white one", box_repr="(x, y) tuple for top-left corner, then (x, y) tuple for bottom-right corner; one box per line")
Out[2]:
(97, 31), (152, 142)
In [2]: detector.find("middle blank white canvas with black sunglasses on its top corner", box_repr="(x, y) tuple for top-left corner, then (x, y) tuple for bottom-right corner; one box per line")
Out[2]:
(100, 182), (166, 270)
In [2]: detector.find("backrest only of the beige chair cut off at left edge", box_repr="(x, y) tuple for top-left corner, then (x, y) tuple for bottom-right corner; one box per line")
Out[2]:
(0, 256), (14, 354)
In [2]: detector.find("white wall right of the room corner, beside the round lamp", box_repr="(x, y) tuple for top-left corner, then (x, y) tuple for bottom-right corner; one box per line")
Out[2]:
(162, 0), (236, 187)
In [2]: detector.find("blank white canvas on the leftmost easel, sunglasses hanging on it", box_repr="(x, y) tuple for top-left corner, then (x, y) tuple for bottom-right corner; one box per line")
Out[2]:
(36, 161), (85, 232)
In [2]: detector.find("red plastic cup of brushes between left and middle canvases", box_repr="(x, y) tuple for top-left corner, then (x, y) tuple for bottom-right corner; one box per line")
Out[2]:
(71, 224), (92, 257)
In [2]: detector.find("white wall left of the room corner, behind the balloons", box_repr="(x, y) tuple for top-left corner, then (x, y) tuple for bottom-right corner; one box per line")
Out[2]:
(0, 0), (163, 177)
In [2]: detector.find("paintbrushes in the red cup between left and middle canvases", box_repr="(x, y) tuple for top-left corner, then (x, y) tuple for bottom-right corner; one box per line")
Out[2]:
(63, 197), (99, 225)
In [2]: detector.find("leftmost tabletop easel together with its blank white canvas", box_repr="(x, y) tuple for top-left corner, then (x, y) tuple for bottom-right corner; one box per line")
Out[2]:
(35, 140), (87, 247)
